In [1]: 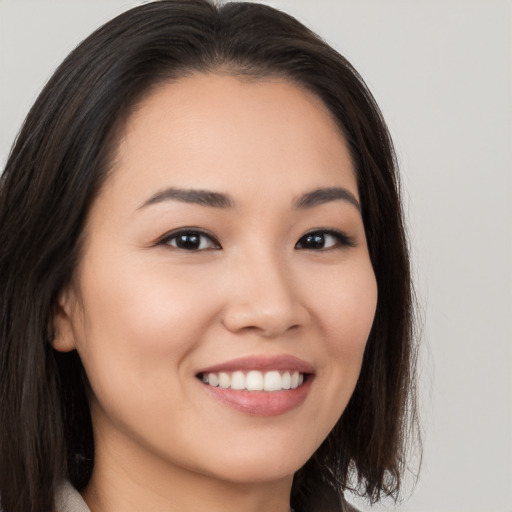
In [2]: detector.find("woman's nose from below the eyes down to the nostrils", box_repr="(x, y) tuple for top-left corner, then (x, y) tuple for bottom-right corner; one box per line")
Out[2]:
(223, 251), (310, 338)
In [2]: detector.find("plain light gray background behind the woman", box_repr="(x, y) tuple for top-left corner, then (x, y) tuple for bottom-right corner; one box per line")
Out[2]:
(0, 0), (512, 512)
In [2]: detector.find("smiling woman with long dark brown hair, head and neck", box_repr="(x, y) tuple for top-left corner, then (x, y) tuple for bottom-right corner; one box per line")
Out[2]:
(0, 0), (415, 512)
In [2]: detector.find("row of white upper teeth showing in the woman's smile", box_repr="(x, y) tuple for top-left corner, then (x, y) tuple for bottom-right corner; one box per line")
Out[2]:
(202, 370), (304, 391)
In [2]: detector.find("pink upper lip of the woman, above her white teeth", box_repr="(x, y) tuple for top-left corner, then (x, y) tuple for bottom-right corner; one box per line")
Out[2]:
(198, 354), (314, 374)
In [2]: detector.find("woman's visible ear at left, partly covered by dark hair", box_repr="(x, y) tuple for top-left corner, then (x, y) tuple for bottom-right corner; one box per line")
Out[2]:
(51, 285), (77, 352)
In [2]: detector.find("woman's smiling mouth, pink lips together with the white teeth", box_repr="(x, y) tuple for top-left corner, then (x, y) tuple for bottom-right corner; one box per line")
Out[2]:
(196, 355), (314, 416)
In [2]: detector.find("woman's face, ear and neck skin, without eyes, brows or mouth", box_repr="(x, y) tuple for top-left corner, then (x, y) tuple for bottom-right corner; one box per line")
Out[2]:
(54, 74), (377, 512)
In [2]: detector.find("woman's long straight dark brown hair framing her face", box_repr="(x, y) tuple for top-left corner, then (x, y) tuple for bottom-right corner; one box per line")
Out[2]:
(0, 0), (416, 512)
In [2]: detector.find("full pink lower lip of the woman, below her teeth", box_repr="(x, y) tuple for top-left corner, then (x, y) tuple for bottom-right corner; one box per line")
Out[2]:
(201, 375), (313, 416)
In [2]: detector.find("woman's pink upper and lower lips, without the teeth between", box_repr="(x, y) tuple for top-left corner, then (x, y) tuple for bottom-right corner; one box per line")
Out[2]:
(198, 355), (314, 416)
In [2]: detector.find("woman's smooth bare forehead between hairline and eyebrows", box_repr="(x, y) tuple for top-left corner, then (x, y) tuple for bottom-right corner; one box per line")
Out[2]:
(102, 74), (357, 208)
